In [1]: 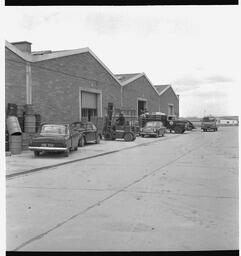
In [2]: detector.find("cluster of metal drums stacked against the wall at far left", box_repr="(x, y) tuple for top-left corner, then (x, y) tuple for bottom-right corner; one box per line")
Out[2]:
(5, 103), (41, 154)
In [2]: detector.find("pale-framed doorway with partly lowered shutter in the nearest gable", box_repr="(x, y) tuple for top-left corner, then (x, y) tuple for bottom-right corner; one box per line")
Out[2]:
(79, 89), (102, 121)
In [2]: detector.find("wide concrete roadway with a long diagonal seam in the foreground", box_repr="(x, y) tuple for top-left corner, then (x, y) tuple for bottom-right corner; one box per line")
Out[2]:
(6, 127), (238, 251)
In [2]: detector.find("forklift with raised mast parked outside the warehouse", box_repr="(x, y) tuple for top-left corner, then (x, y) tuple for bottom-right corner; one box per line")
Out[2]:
(103, 103), (136, 141)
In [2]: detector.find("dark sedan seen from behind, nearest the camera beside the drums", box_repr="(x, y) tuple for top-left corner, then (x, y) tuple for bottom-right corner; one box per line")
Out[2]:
(29, 123), (80, 156)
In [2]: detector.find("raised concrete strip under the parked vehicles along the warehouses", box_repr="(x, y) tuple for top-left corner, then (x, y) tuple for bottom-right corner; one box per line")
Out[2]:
(6, 132), (181, 179)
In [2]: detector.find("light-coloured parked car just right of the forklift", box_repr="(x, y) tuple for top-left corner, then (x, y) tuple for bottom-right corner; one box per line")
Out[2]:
(140, 121), (166, 137)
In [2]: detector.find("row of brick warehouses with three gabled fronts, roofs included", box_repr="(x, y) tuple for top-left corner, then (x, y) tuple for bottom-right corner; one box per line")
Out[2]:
(5, 41), (179, 122)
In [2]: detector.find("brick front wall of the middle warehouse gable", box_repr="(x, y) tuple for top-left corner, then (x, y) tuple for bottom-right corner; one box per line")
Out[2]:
(123, 76), (159, 113)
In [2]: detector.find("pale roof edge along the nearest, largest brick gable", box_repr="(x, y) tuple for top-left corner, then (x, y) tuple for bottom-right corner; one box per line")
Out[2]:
(5, 41), (122, 85)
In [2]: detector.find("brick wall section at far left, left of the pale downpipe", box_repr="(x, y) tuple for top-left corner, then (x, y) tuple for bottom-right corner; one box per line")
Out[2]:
(5, 48), (26, 106)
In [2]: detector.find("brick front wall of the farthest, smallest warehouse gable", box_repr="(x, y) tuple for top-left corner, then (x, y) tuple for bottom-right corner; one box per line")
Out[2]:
(160, 88), (179, 117)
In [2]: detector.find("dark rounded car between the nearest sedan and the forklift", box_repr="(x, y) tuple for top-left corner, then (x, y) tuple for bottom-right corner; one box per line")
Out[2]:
(71, 122), (102, 147)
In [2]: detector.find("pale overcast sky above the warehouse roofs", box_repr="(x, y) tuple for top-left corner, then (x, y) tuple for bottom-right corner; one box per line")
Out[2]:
(4, 6), (241, 116)
